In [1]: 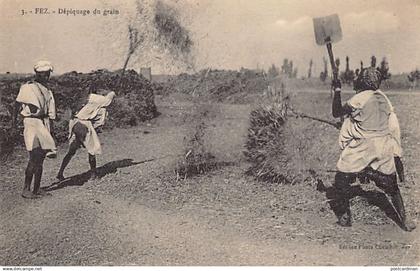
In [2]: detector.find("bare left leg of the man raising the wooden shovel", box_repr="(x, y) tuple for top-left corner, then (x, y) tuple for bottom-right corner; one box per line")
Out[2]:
(330, 172), (356, 227)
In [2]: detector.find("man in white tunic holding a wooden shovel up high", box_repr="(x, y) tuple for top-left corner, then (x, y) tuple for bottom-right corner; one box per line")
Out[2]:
(314, 15), (415, 231)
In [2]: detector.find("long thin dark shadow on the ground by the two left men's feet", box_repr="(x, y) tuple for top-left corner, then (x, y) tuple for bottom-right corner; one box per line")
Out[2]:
(43, 158), (155, 191)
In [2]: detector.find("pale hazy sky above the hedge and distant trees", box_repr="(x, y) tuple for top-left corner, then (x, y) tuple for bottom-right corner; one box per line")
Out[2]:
(0, 0), (420, 75)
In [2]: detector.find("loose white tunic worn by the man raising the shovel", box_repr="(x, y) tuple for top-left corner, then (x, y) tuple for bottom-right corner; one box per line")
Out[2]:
(337, 90), (401, 174)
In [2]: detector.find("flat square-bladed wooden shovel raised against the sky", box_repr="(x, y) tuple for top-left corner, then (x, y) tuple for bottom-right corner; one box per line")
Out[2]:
(313, 14), (343, 90)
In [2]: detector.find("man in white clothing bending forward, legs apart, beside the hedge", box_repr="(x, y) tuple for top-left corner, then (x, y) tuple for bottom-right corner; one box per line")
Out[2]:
(57, 91), (115, 180)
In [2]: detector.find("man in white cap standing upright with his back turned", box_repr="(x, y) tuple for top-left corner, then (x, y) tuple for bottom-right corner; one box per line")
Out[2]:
(12, 61), (57, 198)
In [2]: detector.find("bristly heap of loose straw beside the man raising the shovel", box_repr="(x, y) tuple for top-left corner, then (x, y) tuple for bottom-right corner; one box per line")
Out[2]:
(244, 87), (339, 184)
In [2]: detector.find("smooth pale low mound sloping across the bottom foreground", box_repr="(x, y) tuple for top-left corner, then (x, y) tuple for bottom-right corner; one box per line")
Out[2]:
(1, 189), (414, 265)
